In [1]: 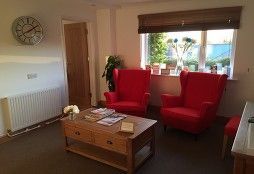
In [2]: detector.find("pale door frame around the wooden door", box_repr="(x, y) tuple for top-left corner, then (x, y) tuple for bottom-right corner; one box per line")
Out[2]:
(60, 17), (97, 106)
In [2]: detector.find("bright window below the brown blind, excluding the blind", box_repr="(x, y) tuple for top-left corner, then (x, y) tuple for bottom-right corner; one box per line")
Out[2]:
(141, 29), (236, 77)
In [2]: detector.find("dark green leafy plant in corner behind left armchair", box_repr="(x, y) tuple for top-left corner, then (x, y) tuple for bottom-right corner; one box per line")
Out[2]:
(102, 56), (122, 91)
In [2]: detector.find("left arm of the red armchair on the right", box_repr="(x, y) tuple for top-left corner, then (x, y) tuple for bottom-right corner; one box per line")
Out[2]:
(161, 94), (182, 108)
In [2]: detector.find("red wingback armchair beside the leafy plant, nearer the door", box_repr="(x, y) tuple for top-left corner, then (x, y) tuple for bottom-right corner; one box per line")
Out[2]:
(104, 69), (151, 117)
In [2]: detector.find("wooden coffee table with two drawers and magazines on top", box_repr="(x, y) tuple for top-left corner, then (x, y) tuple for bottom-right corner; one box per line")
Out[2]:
(61, 108), (157, 174)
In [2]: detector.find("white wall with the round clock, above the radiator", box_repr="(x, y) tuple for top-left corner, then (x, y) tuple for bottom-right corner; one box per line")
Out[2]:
(0, 0), (97, 135)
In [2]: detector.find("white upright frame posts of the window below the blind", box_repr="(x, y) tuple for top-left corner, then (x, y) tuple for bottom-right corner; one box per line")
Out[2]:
(140, 29), (237, 78)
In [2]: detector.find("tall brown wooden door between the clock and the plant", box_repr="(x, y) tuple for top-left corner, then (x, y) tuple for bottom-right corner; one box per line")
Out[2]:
(64, 23), (91, 110)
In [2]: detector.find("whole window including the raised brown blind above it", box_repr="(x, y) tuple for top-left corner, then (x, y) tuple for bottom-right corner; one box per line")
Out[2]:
(138, 6), (242, 77)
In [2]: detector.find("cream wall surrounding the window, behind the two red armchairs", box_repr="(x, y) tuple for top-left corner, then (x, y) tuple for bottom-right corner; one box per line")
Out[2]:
(98, 0), (254, 115)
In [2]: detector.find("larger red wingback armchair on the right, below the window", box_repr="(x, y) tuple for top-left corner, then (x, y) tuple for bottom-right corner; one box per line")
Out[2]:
(160, 71), (227, 135)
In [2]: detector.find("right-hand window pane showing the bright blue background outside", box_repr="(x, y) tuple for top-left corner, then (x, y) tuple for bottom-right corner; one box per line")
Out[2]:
(205, 29), (234, 75)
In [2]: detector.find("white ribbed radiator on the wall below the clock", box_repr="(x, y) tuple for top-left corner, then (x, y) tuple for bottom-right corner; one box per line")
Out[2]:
(3, 87), (62, 132)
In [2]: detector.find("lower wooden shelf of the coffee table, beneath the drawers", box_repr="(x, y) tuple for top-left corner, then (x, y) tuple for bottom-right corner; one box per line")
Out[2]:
(65, 142), (153, 172)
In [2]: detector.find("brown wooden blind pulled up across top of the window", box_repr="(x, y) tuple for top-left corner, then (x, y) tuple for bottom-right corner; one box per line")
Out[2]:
(138, 6), (242, 33)
